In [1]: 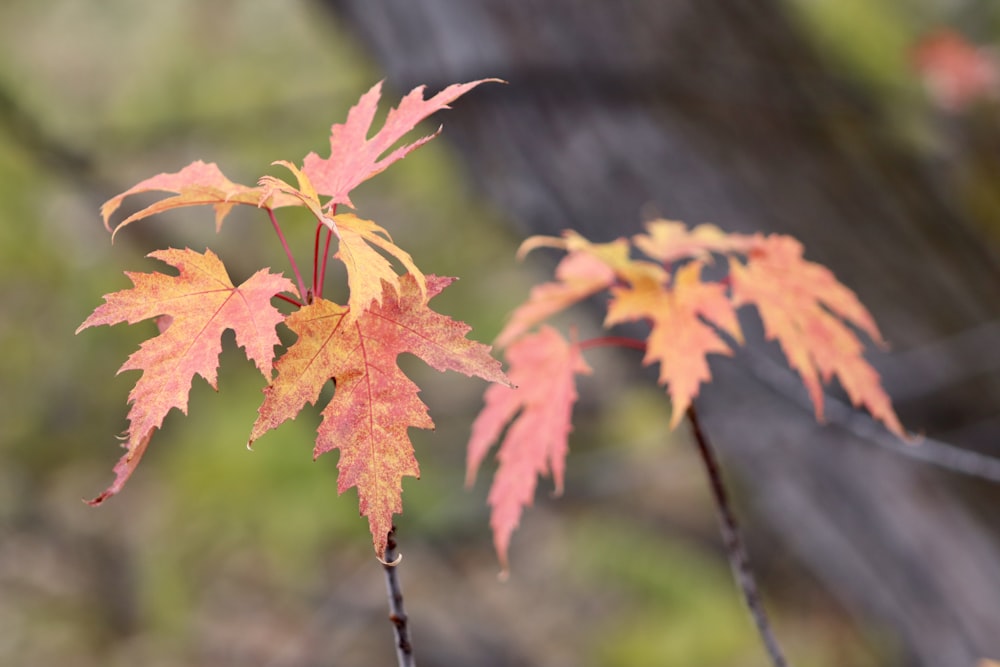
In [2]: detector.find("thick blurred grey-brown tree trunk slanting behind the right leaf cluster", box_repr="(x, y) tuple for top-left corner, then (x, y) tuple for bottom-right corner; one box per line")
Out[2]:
(322, 0), (1000, 667)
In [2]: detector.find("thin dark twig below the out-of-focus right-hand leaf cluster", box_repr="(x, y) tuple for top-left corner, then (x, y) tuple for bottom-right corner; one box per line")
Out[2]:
(687, 406), (788, 667)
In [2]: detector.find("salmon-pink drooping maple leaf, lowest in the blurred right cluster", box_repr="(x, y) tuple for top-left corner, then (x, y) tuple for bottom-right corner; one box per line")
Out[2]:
(466, 326), (591, 572)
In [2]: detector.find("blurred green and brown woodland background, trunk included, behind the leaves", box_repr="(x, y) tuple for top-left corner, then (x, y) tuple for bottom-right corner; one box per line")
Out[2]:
(0, 0), (1000, 667)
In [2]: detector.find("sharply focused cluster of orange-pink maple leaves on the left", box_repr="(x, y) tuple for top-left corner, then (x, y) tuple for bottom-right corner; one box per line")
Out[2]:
(77, 81), (507, 557)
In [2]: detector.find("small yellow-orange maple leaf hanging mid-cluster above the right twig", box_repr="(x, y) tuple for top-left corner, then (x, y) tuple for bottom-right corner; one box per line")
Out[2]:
(604, 261), (743, 428)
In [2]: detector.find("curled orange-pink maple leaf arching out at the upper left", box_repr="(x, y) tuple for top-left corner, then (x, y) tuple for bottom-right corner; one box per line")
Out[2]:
(101, 160), (300, 236)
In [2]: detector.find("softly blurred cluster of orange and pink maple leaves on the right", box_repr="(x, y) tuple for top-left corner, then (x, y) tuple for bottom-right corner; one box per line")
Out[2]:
(467, 220), (905, 570)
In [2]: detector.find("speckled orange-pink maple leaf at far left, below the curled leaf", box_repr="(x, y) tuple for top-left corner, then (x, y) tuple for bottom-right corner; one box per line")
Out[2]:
(77, 249), (295, 504)
